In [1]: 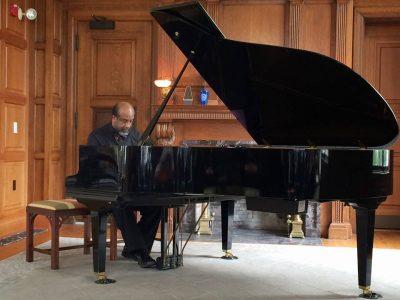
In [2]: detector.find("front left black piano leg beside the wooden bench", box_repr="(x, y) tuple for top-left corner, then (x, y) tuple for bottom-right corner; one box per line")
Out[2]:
(91, 211), (115, 284)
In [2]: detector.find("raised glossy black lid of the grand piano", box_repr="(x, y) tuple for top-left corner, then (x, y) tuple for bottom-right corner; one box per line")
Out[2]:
(151, 2), (399, 148)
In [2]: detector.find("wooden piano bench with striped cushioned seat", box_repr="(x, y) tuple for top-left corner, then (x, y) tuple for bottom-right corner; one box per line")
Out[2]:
(26, 199), (92, 270)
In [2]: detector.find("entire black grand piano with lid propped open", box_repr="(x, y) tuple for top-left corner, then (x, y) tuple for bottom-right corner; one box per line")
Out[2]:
(66, 2), (399, 298)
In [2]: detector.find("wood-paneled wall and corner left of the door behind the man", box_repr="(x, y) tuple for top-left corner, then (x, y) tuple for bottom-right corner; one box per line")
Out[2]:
(0, 0), (66, 236)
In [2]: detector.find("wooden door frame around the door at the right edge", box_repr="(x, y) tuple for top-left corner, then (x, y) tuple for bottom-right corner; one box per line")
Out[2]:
(350, 2), (400, 228)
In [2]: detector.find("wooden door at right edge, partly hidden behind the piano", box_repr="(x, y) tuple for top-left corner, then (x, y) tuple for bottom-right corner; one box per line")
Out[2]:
(363, 22), (400, 228)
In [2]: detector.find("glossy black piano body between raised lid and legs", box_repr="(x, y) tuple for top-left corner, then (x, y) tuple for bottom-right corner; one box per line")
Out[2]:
(67, 146), (393, 205)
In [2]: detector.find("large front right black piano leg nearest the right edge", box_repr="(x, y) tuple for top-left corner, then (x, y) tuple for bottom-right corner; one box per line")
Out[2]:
(355, 199), (382, 299)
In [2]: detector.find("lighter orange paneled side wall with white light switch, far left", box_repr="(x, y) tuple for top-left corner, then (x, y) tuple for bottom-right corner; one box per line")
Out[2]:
(0, 0), (30, 236)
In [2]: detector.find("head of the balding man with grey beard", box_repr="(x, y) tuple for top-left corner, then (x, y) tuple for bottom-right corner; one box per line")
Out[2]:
(111, 102), (135, 136)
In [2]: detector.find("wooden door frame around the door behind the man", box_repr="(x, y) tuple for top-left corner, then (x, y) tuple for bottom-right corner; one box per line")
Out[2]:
(65, 9), (157, 176)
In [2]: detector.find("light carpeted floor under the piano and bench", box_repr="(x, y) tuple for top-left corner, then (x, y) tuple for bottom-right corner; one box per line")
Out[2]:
(0, 238), (400, 300)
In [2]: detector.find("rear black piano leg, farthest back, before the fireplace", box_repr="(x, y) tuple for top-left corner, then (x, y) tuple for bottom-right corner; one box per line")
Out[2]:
(221, 200), (237, 259)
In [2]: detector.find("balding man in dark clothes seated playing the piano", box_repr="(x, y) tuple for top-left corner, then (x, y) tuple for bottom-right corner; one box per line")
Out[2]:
(88, 102), (161, 268)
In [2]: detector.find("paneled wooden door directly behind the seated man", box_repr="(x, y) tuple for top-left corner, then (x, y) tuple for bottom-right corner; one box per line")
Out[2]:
(76, 21), (151, 151)
